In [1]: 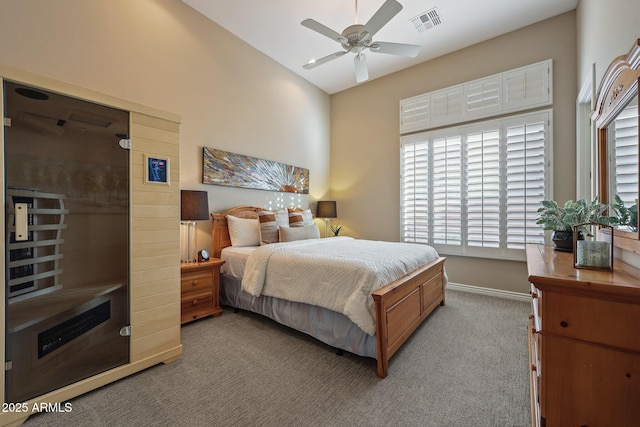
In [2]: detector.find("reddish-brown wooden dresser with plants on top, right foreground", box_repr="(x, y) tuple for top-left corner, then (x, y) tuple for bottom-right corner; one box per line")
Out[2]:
(527, 245), (640, 427)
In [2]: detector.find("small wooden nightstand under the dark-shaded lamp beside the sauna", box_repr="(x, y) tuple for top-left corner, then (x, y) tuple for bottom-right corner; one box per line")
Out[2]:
(180, 258), (224, 324)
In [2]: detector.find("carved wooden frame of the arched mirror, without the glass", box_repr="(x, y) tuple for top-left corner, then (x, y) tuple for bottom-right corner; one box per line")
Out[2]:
(591, 39), (640, 253)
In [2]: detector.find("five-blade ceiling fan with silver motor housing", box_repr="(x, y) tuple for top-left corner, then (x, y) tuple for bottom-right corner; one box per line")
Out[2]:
(301, 0), (420, 83)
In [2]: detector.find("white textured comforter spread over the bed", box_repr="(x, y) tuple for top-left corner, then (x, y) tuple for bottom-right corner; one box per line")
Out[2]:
(242, 236), (438, 335)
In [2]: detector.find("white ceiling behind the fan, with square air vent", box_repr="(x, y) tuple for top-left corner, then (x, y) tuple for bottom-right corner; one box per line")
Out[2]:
(182, 0), (578, 94)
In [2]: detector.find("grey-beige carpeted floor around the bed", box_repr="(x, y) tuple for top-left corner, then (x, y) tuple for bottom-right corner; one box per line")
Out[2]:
(25, 291), (531, 427)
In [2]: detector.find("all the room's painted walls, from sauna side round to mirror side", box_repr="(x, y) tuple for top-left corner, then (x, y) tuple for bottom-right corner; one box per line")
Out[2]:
(0, 0), (640, 292)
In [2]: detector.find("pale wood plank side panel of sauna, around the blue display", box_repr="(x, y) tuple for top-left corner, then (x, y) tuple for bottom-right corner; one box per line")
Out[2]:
(129, 113), (180, 362)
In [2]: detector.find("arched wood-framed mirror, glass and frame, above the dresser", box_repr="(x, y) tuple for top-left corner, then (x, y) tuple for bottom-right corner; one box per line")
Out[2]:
(591, 39), (640, 250)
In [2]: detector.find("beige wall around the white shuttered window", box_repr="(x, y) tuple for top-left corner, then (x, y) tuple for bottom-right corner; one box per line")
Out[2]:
(331, 12), (577, 292)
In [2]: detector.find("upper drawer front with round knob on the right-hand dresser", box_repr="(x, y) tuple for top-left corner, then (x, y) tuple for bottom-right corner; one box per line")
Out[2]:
(542, 292), (640, 353)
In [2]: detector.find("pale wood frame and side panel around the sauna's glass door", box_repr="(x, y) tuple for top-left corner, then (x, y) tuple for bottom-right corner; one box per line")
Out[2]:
(0, 64), (182, 426)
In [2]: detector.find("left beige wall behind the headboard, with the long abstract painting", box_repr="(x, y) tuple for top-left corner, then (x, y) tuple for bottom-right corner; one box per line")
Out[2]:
(0, 0), (330, 254)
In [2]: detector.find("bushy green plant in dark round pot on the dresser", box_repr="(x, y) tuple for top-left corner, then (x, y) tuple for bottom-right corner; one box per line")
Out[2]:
(536, 197), (617, 252)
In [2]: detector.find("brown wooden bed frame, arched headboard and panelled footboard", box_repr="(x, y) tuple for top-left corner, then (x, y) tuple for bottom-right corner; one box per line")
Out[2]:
(211, 206), (445, 378)
